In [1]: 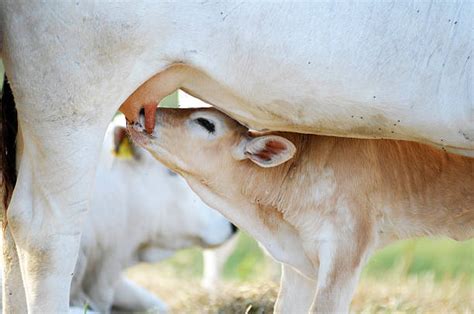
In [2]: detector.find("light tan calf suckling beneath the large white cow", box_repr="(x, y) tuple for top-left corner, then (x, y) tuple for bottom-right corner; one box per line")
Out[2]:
(128, 109), (474, 313)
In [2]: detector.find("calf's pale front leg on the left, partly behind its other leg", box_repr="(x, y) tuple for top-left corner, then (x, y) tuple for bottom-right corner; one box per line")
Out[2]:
(275, 264), (316, 314)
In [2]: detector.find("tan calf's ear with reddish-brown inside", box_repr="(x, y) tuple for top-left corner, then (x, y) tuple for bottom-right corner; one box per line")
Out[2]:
(244, 135), (296, 168)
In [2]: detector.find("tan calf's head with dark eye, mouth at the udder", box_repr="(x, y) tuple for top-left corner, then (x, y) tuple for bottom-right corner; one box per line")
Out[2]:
(128, 108), (296, 194)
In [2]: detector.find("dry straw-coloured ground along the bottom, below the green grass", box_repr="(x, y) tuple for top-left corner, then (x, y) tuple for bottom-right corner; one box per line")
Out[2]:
(128, 266), (474, 314)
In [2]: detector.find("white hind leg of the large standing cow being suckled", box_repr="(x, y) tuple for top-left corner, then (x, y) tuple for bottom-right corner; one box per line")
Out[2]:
(7, 121), (107, 313)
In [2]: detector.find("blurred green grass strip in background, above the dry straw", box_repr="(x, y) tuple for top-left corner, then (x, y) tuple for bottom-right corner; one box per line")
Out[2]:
(158, 234), (474, 283)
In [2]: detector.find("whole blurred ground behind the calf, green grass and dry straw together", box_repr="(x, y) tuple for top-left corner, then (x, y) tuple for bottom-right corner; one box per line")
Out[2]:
(127, 236), (474, 314)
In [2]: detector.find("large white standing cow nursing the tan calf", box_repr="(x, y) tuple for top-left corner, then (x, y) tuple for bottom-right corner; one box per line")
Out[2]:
(0, 0), (474, 313)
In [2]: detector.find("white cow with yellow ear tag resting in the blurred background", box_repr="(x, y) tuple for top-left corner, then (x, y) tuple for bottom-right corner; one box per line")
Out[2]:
(0, 119), (236, 313)
